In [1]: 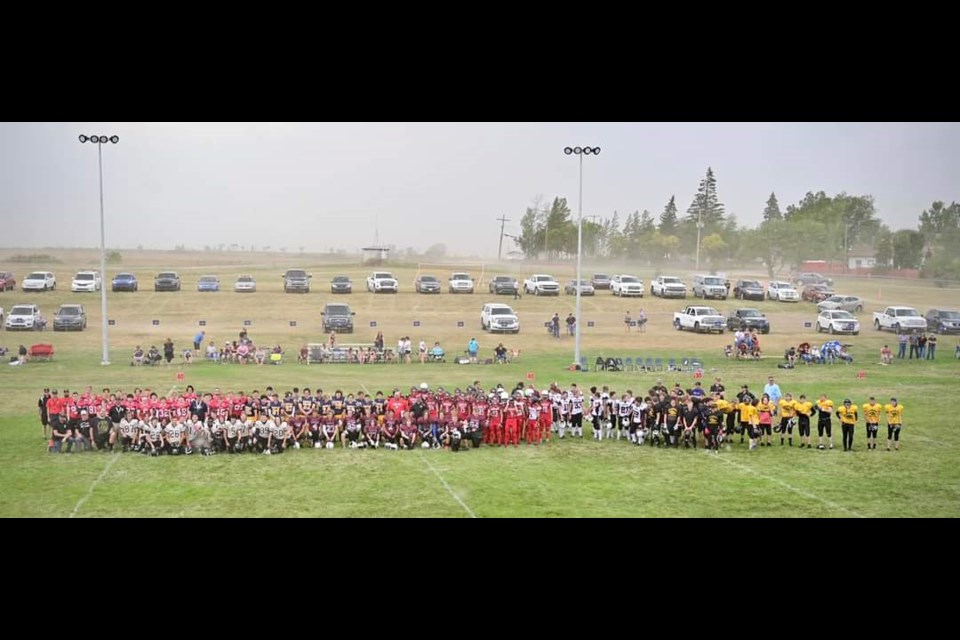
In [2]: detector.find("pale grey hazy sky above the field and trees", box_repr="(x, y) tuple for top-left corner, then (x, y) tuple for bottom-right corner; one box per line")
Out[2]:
(0, 123), (960, 256)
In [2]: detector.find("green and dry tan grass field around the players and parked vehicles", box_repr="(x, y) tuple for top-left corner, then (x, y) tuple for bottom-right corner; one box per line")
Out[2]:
(0, 252), (960, 517)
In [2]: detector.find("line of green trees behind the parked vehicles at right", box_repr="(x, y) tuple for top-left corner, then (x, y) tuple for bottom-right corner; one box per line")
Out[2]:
(515, 168), (960, 279)
